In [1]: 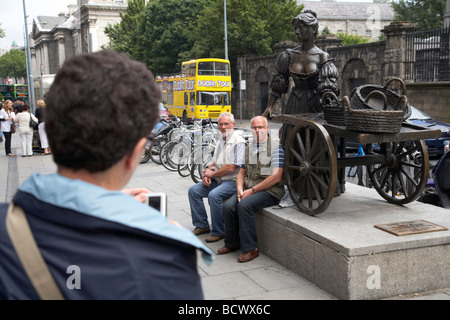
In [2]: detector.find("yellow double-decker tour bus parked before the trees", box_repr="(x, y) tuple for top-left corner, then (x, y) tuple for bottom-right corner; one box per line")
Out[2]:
(157, 58), (231, 122)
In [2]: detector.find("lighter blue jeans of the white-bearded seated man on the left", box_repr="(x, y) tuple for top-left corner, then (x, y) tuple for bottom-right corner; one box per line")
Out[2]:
(188, 179), (236, 236)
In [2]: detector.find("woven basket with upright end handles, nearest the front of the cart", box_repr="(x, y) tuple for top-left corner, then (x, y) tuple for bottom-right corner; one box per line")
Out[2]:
(342, 90), (408, 133)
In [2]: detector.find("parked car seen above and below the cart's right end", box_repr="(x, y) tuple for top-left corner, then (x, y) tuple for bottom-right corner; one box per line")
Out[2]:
(406, 106), (450, 157)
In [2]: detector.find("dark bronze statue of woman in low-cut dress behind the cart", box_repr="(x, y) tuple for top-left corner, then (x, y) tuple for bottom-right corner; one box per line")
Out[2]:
(263, 10), (339, 118)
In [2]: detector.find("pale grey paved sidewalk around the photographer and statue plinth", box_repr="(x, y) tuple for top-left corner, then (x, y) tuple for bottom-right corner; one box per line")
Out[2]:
(0, 132), (450, 300)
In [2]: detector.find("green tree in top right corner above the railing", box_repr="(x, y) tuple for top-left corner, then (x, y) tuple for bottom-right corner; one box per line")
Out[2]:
(392, 0), (446, 29)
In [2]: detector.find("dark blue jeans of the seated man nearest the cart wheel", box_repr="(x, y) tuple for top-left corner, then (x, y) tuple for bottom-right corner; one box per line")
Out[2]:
(223, 191), (280, 252)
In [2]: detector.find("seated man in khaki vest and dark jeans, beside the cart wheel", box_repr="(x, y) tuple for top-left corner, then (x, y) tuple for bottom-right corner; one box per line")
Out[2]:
(218, 116), (284, 262)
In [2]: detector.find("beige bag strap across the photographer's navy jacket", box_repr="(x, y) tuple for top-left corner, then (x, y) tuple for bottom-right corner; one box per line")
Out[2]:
(6, 202), (64, 300)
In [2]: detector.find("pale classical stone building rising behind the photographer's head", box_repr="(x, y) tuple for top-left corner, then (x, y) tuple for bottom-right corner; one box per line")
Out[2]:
(30, 0), (128, 98)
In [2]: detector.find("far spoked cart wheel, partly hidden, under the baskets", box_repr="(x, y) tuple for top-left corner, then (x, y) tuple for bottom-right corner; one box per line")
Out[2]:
(367, 140), (430, 205)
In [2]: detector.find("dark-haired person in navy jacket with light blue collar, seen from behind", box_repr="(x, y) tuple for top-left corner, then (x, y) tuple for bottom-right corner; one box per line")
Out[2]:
(0, 51), (212, 300)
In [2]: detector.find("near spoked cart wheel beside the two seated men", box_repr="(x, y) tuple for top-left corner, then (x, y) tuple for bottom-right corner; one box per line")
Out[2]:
(285, 121), (338, 216)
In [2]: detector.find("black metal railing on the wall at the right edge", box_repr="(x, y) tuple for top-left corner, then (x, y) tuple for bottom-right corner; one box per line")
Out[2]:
(405, 28), (450, 82)
